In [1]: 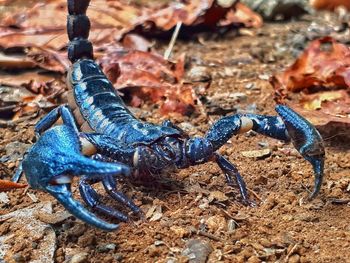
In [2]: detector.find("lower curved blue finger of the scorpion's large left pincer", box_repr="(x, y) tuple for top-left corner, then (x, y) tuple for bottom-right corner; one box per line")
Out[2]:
(46, 184), (119, 231)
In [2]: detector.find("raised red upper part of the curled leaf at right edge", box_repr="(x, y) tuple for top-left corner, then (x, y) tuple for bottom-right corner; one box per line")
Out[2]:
(272, 37), (350, 95)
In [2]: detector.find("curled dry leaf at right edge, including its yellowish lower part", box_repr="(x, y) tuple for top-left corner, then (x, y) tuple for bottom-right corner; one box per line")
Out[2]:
(270, 37), (350, 131)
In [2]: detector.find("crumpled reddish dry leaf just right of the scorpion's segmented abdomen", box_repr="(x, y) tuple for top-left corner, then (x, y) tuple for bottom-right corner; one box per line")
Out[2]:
(100, 49), (196, 114)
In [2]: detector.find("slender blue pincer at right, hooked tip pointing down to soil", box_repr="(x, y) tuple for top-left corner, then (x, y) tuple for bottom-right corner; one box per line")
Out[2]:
(276, 105), (325, 199)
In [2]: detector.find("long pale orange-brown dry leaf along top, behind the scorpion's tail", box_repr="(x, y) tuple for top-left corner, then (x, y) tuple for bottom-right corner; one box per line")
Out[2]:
(0, 0), (260, 51)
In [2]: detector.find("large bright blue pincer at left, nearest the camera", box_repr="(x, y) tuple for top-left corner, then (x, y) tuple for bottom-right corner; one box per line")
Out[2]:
(12, 107), (130, 231)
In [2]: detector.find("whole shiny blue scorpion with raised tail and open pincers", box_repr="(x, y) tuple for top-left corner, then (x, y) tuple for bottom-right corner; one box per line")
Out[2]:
(16, 0), (325, 230)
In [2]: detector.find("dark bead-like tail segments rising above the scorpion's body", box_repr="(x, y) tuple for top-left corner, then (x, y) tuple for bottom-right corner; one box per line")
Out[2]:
(67, 0), (93, 63)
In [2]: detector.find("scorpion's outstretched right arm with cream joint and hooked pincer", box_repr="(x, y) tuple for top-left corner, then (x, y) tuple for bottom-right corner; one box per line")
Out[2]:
(205, 105), (325, 198)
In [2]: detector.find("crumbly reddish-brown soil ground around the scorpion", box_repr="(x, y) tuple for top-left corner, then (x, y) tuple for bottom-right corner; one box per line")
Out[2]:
(0, 13), (350, 263)
